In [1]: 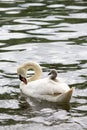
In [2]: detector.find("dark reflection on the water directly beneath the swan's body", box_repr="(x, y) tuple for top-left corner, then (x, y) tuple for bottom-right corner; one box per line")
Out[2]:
(19, 94), (71, 111)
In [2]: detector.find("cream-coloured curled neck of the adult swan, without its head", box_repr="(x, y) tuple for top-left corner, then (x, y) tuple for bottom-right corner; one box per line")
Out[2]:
(22, 62), (42, 82)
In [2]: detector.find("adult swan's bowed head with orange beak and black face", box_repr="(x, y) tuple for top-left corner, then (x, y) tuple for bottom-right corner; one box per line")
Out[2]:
(17, 67), (27, 84)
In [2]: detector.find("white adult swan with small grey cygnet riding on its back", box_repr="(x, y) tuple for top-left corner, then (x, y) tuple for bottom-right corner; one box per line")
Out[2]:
(17, 61), (73, 103)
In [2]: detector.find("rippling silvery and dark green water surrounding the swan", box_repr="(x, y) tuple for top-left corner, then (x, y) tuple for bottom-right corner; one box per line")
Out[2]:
(0, 0), (87, 130)
